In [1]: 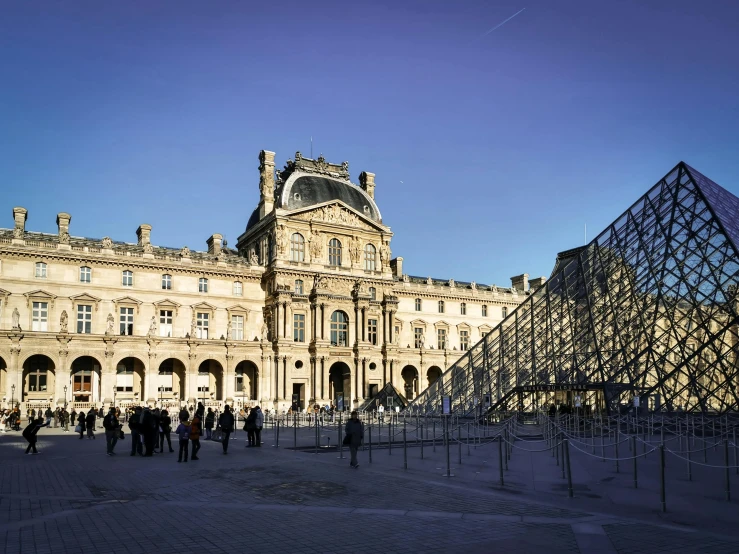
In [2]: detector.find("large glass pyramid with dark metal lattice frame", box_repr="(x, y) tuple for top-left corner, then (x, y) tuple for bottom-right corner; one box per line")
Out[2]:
(409, 162), (739, 415)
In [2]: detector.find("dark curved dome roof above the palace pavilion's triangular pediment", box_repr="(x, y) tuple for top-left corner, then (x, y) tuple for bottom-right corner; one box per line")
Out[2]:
(278, 173), (382, 223)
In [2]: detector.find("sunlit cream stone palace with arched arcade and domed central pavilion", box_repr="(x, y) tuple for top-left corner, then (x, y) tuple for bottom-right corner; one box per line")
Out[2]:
(0, 151), (544, 410)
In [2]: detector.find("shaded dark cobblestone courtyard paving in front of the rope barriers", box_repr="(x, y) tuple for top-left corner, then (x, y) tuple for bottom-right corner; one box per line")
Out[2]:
(0, 420), (739, 554)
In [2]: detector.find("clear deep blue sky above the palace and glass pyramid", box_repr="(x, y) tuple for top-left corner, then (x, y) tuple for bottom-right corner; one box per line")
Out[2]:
(0, 0), (739, 286)
